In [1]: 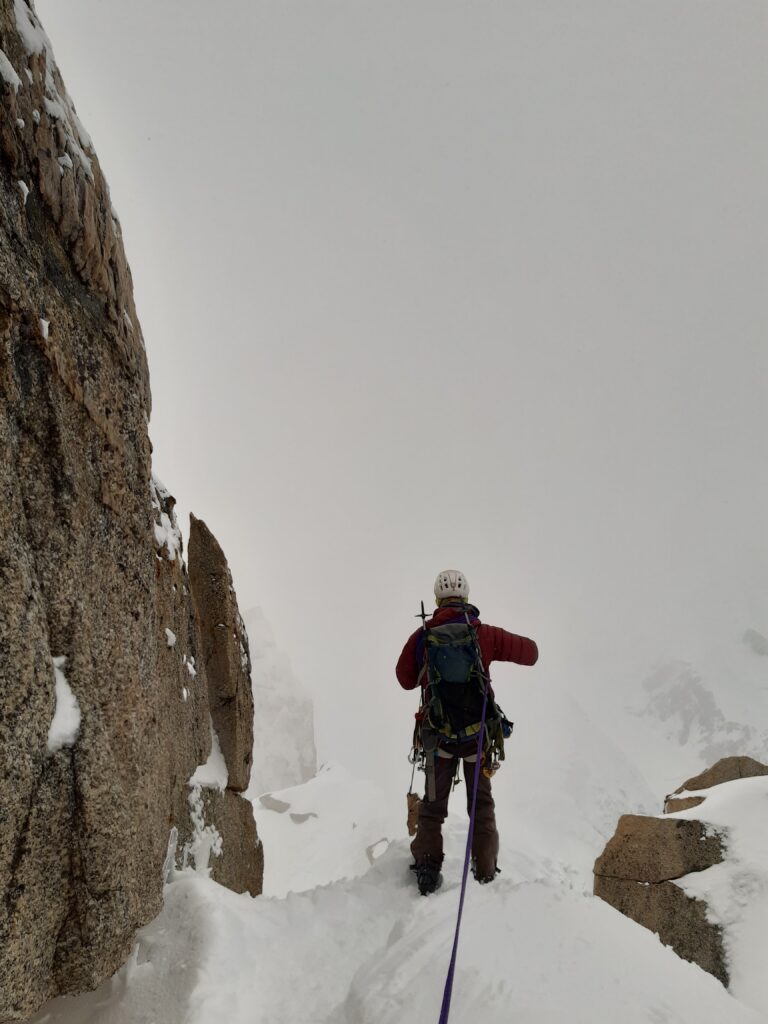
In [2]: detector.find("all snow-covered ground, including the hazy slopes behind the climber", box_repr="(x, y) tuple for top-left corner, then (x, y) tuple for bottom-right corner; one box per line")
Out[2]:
(27, 598), (768, 1024)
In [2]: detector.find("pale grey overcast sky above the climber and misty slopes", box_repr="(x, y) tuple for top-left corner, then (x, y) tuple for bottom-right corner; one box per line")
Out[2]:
(37, 0), (768, 785)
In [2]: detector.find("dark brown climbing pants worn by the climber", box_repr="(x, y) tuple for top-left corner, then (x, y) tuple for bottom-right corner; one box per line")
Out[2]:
(411, 741), (499, 878)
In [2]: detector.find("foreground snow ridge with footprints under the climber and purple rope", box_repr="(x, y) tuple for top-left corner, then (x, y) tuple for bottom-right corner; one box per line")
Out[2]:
(30, 765), (768, 1024)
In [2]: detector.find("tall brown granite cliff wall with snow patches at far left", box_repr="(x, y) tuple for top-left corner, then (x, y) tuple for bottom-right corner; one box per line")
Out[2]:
(0, 0), (260, 1021)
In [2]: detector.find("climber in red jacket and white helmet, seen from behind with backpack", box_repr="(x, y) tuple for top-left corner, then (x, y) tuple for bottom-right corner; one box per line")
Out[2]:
(395, 569), (539, 895)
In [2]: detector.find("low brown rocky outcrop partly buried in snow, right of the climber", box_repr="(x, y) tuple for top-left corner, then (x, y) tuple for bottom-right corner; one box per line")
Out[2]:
(594, 758), (768, 986)
